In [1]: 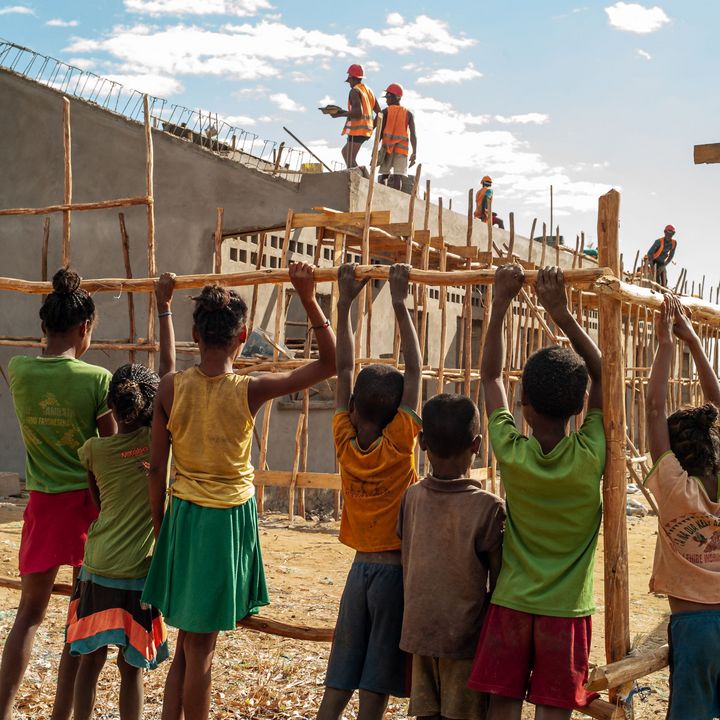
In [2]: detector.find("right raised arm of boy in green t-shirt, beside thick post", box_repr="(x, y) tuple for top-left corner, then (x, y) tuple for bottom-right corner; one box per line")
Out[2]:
(535, 267), (602, 408)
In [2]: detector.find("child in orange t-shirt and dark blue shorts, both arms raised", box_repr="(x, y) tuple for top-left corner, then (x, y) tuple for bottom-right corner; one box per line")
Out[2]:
(318, 265), (422, 720)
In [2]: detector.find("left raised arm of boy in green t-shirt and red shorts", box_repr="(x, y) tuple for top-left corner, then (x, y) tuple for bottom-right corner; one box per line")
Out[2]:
(480, 263), (525, 416)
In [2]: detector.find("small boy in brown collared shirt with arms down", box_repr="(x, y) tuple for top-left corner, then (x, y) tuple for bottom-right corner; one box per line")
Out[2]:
(398, 394), (505, 720)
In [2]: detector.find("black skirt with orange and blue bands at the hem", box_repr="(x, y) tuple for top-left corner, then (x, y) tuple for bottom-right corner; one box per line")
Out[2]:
(65, 567), (168, 670)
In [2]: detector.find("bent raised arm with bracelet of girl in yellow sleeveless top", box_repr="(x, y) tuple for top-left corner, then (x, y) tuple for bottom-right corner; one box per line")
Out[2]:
(248, 263), (335, 415)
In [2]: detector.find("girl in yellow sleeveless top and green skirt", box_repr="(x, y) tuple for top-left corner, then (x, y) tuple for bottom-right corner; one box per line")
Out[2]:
(143, 263), (335, 720)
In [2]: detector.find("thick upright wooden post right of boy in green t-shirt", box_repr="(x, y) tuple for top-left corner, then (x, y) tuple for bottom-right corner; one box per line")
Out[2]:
(598, 190), (630, 699)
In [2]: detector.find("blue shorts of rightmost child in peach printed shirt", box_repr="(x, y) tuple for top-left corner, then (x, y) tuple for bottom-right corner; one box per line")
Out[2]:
(667, 611), (720, 720)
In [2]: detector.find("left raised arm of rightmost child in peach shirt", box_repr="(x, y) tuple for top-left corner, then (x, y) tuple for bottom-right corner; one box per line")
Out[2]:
(645, 295), (675, 462)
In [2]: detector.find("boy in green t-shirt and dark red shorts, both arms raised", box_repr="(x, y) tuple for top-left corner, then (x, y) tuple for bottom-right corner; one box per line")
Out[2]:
(469, 264), (605, 720)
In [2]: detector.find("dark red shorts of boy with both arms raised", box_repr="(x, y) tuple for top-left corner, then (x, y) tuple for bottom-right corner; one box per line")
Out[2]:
(468, 604), (599, 708)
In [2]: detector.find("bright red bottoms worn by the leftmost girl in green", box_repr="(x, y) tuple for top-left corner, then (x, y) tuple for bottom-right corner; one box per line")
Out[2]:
(20, 490), (98, 575)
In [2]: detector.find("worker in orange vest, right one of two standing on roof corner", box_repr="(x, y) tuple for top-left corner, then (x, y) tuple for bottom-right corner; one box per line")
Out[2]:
(380, 83), (417, 190)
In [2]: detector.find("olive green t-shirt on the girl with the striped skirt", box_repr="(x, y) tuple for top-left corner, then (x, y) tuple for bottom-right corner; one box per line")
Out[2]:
(78, 427), (153, 578)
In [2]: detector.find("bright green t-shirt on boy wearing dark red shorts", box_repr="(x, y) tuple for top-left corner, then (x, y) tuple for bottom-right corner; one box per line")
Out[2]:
(488, 408), (605, 617)
